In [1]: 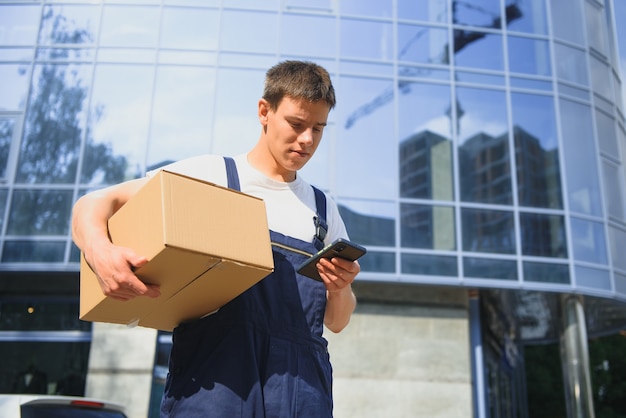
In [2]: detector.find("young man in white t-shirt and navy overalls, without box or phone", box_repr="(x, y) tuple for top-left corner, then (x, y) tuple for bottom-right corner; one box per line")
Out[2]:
(72, 61), (360, 418)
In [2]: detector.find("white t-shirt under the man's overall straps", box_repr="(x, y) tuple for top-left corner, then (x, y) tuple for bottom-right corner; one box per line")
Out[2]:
(148, 154), (348, 244)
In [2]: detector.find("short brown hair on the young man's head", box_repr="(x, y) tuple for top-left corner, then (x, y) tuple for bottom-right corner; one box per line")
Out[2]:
(263, 61), (336, 110)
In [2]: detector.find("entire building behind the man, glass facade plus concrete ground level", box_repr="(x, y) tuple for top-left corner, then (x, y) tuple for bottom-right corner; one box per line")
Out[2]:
(0, 0), (626, 418)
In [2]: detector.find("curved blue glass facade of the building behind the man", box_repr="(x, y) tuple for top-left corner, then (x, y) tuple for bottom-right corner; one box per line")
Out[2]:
(0, 0), (626, 417)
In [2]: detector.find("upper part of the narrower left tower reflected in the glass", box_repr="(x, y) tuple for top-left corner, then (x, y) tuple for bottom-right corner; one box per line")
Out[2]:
(400, 131), (454, 200)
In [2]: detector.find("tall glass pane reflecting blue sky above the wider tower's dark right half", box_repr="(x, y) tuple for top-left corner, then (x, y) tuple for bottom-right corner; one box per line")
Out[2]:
(511, 93), (563, 209)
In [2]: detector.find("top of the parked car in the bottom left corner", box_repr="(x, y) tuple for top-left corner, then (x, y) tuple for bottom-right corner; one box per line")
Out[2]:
(0, 395), (128, 418)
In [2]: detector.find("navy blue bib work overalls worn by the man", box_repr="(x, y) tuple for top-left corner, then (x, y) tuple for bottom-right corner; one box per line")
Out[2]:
(161, 158), (332, 418)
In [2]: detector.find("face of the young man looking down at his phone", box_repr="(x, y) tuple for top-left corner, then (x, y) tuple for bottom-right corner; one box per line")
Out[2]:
(259, 97), (330, 181)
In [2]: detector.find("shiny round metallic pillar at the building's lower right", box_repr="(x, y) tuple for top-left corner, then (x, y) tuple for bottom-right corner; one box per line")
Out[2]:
(560, 295), (595, 418)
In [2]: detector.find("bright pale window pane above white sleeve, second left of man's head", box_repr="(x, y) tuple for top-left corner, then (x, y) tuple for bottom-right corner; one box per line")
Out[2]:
(145, 66), (216, 168)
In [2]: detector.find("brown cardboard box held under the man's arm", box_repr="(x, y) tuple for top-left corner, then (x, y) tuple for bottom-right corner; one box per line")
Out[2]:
(80, 171), (274, 331)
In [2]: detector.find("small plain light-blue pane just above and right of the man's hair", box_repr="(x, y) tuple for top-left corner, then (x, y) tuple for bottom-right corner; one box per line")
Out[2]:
(339, 19), (394, 60)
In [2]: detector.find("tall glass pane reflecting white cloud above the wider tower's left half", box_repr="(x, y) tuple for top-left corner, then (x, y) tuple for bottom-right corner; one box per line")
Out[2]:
(456, 87), (513, 204)
